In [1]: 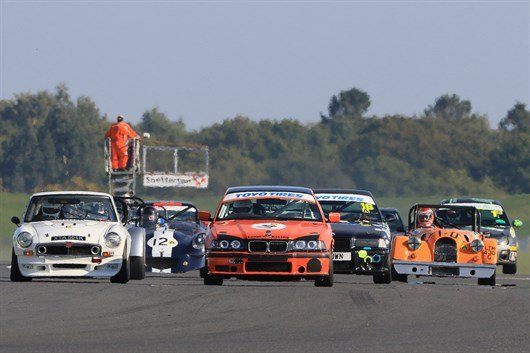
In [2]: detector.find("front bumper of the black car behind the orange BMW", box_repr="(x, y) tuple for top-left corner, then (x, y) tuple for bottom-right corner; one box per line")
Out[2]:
(333, 247), (390, 275)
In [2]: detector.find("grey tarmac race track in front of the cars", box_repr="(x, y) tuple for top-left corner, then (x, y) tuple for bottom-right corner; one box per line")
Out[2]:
(0, 264), (530, 353)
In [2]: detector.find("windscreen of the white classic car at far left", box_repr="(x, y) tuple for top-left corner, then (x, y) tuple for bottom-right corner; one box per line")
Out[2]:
(24, 195), (117, 222)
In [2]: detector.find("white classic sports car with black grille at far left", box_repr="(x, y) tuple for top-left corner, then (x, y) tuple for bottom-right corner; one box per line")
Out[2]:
(11, 191), (145, 283)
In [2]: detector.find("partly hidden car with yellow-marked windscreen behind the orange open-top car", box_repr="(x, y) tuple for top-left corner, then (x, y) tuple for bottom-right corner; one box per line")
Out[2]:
(441, 198), (523, 274)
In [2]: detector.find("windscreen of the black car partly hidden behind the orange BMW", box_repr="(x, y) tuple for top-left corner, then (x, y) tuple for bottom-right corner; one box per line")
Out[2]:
(319, 200), (381, 223)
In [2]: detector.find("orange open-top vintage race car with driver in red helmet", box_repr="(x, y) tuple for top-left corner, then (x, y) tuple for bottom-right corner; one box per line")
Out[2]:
(392, 205), (497, 285)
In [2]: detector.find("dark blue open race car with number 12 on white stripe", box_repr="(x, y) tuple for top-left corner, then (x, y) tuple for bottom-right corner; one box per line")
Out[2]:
(127, 201), (206, 273)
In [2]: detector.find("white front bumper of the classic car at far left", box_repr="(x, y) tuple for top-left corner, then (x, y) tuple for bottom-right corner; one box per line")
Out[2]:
(17, 256), (123, 277)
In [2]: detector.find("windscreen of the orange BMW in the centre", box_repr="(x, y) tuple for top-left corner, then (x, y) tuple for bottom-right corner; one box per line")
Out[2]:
(217, 198), (322, 221)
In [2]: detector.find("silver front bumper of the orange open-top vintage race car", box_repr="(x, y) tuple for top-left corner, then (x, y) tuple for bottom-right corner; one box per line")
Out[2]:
(393, 260), (496, 278)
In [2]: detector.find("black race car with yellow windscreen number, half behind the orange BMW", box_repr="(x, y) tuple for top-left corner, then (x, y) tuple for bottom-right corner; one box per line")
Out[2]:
(314, 189), (392, 283)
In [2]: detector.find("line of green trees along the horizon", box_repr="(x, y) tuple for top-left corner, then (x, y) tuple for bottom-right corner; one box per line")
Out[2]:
(0, 85), (530, 196)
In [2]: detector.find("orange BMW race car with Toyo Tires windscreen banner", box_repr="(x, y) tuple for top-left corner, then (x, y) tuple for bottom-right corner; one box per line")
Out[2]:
(199, 186), (338, 287)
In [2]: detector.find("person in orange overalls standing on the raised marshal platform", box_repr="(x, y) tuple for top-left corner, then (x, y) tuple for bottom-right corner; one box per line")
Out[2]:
(105, 115), (139, 170)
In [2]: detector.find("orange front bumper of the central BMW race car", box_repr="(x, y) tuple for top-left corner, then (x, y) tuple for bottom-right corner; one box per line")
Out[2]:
(206, 251), (331, 278)
